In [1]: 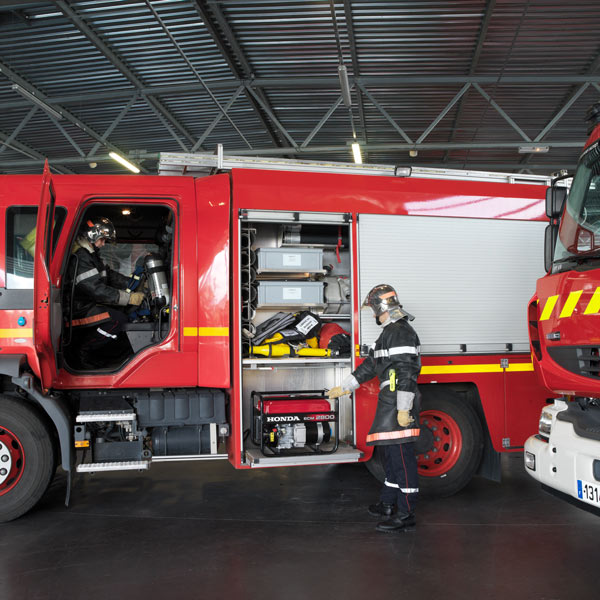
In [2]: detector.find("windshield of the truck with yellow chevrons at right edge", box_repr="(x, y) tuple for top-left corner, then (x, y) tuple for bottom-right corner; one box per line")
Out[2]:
(554, 142), (600, 263)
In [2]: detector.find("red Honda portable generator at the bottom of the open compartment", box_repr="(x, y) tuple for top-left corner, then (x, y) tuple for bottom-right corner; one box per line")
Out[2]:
(252, 390), (339, 455)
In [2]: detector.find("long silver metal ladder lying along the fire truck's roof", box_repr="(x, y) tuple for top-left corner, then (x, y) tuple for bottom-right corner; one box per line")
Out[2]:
(158, 144), (552, 186)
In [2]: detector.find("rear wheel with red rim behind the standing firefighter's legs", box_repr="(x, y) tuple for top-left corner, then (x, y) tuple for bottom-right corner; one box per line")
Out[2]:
(366, 390), (483, 498)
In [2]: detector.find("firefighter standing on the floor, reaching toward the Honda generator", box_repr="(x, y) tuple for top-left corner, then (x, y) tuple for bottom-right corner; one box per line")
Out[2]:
(329, 284), (421, 532)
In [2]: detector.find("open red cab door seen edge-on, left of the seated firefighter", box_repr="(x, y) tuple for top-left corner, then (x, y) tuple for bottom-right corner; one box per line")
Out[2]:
(33, 161), (62, 388)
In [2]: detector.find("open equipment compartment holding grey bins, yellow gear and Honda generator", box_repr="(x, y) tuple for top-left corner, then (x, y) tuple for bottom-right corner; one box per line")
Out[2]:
(239, 211), (360, 466)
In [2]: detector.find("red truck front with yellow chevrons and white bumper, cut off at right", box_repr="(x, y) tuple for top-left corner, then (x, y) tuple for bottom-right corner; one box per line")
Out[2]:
(525, 103), (600, 508)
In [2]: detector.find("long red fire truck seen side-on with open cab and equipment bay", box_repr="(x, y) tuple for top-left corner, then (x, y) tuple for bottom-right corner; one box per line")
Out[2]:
(0, 153), (548, 521)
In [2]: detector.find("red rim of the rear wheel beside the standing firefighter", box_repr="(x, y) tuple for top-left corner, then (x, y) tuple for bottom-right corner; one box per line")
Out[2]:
(417, 410), (463, 477)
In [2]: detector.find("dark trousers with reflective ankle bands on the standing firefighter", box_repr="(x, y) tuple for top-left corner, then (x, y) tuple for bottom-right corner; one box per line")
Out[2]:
(381, 442), (419, 514)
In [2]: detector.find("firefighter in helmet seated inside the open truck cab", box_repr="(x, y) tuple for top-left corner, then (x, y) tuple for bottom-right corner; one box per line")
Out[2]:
(64, 217), (144, 369)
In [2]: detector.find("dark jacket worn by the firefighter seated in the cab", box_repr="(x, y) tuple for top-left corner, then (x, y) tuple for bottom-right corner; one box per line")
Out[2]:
(64, 238), (130, 327)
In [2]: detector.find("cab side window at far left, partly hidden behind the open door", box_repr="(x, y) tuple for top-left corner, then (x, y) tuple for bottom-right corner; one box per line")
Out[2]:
(6, 206), (67, 289)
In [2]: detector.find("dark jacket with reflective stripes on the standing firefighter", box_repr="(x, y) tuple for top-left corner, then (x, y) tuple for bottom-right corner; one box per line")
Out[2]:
(343, 318), (421, 446)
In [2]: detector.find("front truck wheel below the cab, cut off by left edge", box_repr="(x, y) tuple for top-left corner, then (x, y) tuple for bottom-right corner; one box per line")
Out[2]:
(0, 396), (56, 523)
